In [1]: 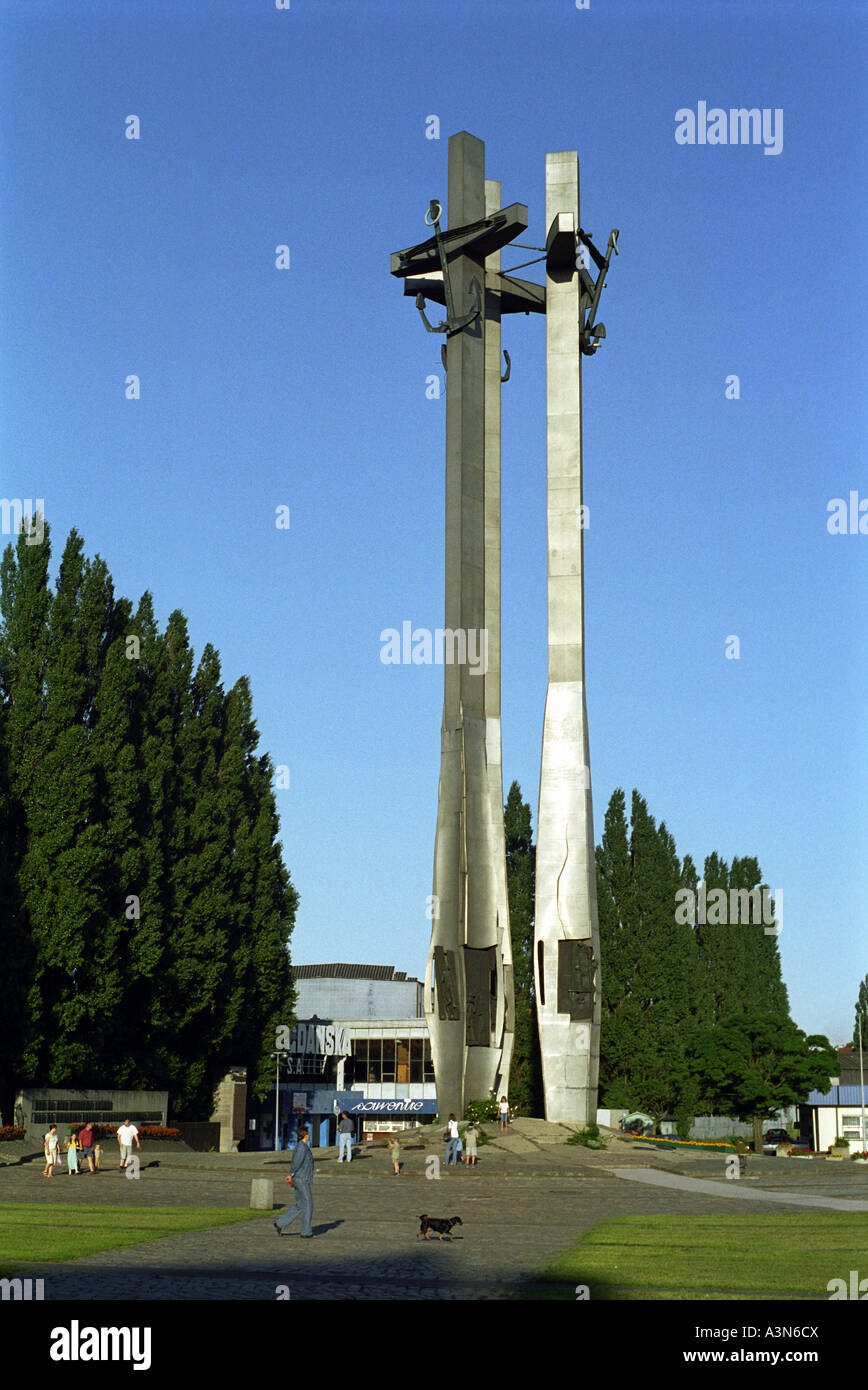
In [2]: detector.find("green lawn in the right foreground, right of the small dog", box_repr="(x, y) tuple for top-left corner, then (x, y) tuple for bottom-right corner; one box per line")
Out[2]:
(531, 1212), (868, 1301)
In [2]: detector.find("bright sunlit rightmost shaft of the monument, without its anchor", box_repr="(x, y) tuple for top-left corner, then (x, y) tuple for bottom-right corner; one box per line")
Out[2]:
(534, 150), (600, 1125)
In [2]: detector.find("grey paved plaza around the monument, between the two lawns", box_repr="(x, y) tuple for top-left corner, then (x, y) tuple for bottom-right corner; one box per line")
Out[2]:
(0, 1122), (868, 1301)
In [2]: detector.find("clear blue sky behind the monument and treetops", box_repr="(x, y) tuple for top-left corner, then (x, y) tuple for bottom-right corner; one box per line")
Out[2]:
(0, 0), (868, 1041)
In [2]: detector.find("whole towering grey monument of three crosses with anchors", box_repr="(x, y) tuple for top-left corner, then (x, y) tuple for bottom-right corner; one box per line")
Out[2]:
(391, 132), (618, 1123)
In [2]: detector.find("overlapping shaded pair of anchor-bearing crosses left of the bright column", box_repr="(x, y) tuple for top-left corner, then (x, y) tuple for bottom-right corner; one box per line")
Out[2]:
(392, 131), (543, 1116)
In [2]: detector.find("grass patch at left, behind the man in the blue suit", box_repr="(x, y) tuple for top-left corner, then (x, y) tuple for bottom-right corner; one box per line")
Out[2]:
(0, 1202), (263, 1277)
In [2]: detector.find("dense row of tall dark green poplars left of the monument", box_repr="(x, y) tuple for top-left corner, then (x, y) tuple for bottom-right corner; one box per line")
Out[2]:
(0, 525), (298, 1118)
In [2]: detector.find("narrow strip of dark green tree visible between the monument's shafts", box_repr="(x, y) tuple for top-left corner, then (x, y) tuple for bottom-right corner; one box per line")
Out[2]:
(504, 781), (544, 1116)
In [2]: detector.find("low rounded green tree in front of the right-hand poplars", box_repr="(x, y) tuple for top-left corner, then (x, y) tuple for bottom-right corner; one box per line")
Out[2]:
(689, 1013), (837, 1152)
